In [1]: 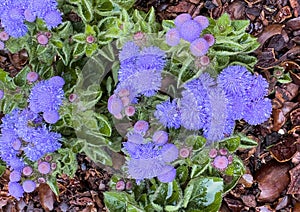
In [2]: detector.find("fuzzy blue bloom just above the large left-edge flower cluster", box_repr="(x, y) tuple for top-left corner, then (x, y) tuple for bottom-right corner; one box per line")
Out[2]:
(29, 76), (64, 113)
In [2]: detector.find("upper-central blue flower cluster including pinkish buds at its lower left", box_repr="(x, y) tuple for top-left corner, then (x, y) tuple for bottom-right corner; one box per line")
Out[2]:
(108, 41), (166, 119)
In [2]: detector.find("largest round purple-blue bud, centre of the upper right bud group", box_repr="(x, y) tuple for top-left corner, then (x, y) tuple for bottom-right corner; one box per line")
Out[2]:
(179, 20), (202, 42)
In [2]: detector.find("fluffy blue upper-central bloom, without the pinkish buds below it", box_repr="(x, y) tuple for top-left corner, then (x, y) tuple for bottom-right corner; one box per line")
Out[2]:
(117, 42), (165, 97)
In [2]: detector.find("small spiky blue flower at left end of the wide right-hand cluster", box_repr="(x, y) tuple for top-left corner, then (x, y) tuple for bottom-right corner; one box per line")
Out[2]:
(154, 99), (181, 129)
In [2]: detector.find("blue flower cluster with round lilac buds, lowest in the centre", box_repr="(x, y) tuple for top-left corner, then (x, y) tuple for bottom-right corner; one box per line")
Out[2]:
(123, 121), (178, 183)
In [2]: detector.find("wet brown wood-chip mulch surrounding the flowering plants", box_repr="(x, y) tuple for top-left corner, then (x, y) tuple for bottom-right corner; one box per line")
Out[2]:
(0, 0), (300, 212)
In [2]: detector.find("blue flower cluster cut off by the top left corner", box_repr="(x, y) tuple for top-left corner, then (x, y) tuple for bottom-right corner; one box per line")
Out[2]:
(0, 0), (62, 38)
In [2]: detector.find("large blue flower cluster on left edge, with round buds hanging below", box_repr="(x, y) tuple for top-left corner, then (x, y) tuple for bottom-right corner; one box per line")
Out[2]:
(0, 109), (61, 199)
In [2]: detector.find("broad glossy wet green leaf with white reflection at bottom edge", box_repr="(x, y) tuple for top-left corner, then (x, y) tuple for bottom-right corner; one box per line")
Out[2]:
(183, 177), (223, 212)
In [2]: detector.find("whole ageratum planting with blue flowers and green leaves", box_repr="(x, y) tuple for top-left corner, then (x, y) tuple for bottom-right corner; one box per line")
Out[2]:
(0, 0), (271, 211)
